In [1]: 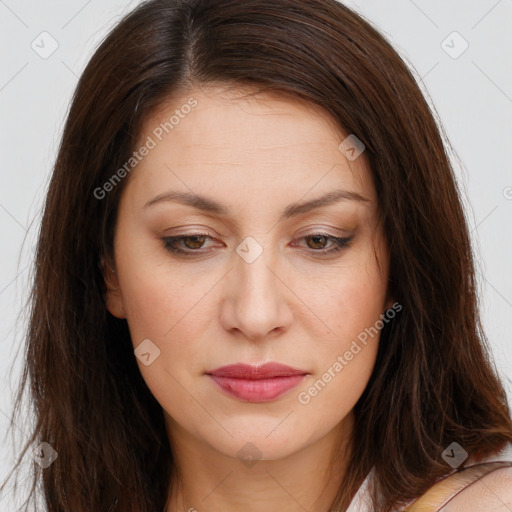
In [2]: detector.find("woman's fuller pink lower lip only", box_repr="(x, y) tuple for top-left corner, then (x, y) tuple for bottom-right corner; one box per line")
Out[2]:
(209, 375), (306, 402)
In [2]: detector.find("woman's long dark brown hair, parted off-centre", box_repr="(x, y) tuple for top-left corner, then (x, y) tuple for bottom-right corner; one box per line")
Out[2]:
(2, 0), (512, 512)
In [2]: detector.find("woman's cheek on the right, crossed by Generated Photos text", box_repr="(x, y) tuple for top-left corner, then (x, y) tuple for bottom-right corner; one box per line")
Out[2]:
(298, 256), (387, 404)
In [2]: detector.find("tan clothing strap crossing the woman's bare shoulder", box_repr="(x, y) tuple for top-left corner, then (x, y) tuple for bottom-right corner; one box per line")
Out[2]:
(404, 461), (512, 512)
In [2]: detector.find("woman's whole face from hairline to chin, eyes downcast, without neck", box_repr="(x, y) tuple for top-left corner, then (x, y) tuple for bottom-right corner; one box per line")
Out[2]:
(107, 86), (391, 460)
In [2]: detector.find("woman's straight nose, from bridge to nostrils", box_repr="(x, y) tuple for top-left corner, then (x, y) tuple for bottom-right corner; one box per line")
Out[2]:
(221, 242), (293, 341)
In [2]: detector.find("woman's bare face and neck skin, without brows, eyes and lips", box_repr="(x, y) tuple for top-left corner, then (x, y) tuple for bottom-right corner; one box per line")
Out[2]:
(106, 85), (393, 512)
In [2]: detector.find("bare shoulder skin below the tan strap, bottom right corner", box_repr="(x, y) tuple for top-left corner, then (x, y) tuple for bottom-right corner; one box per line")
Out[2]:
(440, 467), (512, 512)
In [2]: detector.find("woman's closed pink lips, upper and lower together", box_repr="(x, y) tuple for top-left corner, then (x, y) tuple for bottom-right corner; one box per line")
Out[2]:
(206, 363), (309, 402)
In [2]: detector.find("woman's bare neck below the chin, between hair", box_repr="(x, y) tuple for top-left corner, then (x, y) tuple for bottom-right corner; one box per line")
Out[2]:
(166, 413), (353, 512)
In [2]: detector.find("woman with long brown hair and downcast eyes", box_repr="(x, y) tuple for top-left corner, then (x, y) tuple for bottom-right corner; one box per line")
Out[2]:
(4, 0), (512, 512)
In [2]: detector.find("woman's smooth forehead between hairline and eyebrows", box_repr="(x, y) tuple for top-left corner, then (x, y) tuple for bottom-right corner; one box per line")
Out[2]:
(130, 86), (374, 212)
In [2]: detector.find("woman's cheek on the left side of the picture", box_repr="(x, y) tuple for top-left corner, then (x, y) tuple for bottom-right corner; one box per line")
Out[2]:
(115, 265), (216, 408)
